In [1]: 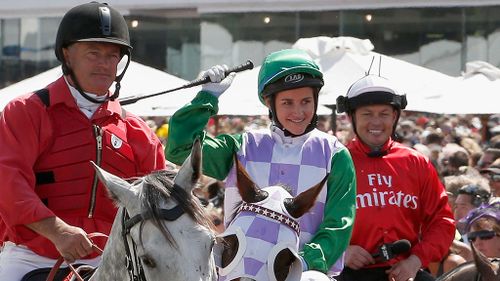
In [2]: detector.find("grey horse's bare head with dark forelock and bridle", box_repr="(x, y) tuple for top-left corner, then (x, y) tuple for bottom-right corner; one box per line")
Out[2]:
(96, 138), (217, 281)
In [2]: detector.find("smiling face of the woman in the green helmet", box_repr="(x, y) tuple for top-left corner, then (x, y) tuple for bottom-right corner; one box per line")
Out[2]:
(267, 87), (315, 135)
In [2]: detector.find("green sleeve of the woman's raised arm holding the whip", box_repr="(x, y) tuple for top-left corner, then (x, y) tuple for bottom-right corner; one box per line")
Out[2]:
(165, 91), (243, 180)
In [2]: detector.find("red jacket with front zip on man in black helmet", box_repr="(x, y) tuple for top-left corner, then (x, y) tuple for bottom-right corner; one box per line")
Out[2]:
(0, 77), (165, 258)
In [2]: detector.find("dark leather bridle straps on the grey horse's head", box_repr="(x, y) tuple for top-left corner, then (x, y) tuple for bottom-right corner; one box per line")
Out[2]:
(121, 184), (184, 281)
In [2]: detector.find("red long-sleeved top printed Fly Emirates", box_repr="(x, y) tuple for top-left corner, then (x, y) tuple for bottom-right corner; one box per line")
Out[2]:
(347, 139), (455, 267)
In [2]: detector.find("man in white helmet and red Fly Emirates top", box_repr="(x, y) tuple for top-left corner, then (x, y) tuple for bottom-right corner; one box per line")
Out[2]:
(337, 75), (455, 281)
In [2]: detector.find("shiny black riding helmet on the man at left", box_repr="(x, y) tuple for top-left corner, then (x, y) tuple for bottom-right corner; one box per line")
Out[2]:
(55, 2), (132, 64)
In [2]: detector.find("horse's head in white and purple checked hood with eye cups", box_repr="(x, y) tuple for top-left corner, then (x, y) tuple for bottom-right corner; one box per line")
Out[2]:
(219, 157), (328, 281)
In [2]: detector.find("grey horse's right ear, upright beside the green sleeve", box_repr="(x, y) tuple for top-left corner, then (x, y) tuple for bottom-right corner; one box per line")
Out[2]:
(174, 138), (202, 192)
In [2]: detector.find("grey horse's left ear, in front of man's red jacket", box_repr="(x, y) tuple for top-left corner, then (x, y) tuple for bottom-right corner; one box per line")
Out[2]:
(90, 161), (136, 205)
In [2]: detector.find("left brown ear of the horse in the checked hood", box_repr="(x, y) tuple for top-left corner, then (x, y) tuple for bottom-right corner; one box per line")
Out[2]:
(234, 153), (267, 203)
